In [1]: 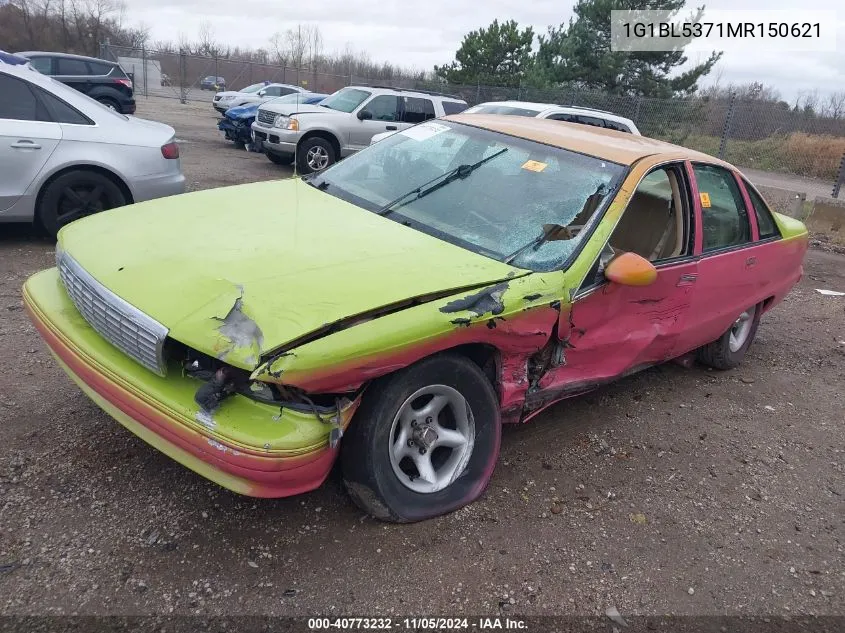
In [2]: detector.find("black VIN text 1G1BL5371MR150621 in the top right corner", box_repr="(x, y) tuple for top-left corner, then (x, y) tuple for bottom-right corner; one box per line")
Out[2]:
(622, 22), (821, 39)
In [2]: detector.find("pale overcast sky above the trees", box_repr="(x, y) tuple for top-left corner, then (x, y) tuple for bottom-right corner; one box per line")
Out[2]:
(126, 0), (845, 100)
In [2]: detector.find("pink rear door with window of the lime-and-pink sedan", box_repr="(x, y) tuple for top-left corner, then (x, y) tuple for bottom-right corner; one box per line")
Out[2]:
(688, 162), (761, 347)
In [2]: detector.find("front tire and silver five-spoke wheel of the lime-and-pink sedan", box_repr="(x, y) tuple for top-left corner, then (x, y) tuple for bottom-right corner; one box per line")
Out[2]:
(341, 354), (502, 523)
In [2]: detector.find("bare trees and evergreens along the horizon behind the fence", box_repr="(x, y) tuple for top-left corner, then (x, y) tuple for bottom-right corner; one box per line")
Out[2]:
(6, 0), (845, 119)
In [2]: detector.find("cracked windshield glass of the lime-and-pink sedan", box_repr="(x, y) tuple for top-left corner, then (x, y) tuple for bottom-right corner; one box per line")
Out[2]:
(309, 120), (630, 272)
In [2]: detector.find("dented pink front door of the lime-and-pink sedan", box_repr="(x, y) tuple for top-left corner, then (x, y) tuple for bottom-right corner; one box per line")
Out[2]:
(538, 163), (698, 397)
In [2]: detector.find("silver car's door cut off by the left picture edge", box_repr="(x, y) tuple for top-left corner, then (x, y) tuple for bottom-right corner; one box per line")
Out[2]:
(0, 72), (62, 213)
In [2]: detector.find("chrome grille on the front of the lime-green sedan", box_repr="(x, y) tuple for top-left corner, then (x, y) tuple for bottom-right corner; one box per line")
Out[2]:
(56, 252), (167, 376)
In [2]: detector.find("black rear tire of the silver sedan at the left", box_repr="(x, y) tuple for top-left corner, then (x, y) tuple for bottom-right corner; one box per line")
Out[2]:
(35, 170), (126, 237)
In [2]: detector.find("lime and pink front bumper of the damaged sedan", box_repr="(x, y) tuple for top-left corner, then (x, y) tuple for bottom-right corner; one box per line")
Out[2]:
(23, 268), (359, 497)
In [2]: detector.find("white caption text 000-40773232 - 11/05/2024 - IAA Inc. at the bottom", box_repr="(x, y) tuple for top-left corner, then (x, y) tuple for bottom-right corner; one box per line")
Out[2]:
(308, 617), (528, 631)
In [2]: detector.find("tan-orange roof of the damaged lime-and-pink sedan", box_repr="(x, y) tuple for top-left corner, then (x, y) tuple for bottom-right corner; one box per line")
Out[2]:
(444, 114), (724, 165)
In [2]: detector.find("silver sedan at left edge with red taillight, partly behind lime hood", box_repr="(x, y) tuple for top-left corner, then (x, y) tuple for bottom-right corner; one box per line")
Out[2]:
(0, 64), (185, 235)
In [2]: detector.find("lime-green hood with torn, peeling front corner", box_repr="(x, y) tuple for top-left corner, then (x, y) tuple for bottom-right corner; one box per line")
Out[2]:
(59, 179), (524, 369)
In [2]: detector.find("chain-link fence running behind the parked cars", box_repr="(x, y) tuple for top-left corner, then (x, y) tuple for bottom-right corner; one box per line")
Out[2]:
(101, 44), (845, 193)
